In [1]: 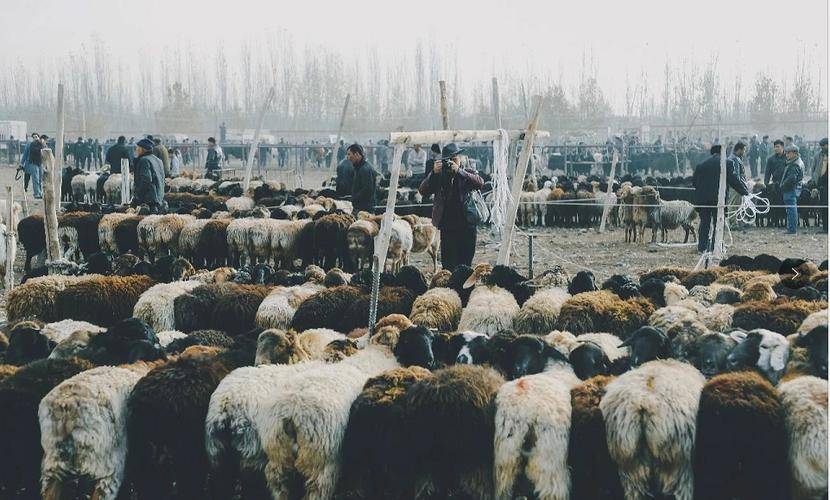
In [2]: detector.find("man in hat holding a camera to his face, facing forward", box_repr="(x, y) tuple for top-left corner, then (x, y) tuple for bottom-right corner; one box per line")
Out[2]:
(418, 143), (484, 271)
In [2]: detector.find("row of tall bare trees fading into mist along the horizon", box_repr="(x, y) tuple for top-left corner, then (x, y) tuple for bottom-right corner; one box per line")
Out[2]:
(0, 31), (826, 136)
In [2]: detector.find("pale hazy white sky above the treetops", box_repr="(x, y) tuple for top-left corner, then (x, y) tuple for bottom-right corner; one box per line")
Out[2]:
(0, 0), (828, 106)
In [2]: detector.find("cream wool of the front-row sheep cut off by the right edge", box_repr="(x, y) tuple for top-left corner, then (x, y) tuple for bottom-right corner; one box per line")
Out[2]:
(778, 376), (827, 498)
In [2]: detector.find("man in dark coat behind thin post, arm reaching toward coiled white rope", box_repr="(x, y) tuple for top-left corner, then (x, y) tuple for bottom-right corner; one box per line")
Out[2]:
(692, 145), (749, 253)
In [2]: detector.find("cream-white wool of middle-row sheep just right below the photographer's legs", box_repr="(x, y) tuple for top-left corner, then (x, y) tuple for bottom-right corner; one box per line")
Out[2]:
(458, 286), (519, 336)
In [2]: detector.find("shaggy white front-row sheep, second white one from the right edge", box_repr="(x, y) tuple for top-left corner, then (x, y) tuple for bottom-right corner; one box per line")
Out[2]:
(599, 360), (705, 500)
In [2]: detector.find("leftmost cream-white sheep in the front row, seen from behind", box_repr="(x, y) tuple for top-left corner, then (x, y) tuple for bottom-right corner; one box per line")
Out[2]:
(38, 363), (159, 500)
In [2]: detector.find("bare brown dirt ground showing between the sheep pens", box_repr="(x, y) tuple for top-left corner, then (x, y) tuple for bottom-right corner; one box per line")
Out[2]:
(0, 160), (828, 322)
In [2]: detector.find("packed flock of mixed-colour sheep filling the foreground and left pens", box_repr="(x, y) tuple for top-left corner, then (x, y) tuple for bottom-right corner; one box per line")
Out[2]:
(0, 173), (828, 500)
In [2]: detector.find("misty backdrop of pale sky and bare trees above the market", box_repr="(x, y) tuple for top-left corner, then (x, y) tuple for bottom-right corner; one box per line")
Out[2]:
(0, 0), (827, 139)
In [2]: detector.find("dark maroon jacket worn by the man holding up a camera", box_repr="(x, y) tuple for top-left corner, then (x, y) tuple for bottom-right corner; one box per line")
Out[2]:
(418, 162), (484, 229)
